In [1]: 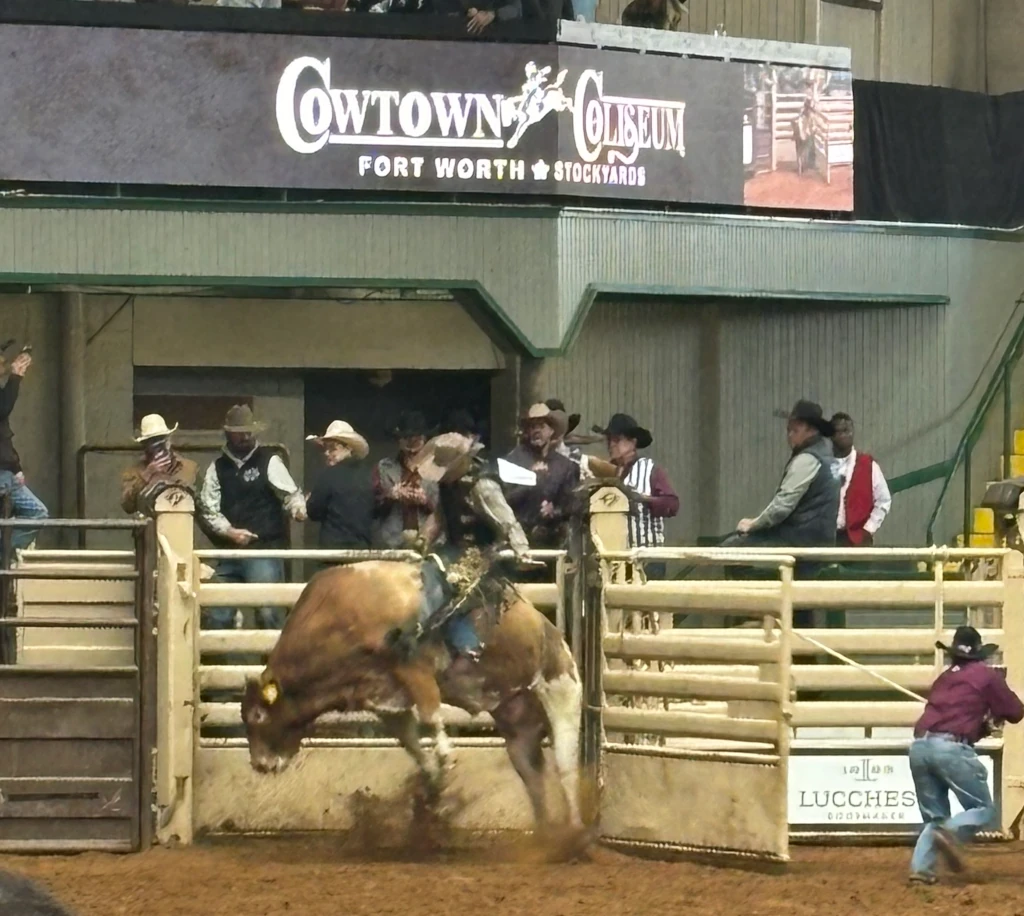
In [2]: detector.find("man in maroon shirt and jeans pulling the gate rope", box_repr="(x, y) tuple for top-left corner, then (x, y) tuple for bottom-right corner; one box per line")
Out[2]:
(910, 626), (1024, 884)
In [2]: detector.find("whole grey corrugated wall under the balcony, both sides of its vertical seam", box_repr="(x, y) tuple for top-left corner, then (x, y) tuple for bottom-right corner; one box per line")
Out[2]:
(540, 300), (948, 544)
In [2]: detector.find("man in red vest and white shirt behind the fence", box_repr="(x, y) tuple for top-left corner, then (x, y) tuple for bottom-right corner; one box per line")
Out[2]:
(831, 413), (893, 548)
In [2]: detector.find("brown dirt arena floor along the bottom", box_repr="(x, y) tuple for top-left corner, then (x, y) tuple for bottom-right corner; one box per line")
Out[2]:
(0, 835), (1024, 916)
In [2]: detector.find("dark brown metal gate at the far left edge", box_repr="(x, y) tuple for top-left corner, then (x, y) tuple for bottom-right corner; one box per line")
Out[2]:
(0, 519), (156, 853)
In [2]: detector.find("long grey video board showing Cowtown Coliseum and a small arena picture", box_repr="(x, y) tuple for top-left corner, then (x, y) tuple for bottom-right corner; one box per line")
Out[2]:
(0, 26), (853, 210)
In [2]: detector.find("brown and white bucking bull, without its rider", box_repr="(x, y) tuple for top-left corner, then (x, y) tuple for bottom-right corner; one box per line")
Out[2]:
(234, 561), (583, 831)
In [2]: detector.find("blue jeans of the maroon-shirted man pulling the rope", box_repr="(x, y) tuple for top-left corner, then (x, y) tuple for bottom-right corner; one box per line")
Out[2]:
(910, 736), (995, 875)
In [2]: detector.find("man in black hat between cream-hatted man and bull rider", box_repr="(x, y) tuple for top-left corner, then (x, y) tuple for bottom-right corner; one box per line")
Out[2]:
(373, 410), (438, 550)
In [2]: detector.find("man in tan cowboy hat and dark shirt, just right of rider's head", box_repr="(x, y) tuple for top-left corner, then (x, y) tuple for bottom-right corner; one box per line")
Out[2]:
(506, 403), (580, 550)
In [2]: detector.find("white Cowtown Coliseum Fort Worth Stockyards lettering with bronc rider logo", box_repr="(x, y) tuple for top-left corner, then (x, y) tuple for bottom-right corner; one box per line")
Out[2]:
(276, 56), (686, 186)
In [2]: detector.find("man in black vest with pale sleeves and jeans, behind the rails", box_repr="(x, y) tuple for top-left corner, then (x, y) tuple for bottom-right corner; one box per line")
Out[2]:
(198, 404), (306, 629)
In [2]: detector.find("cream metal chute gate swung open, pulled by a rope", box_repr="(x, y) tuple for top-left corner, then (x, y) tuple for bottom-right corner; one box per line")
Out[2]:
(584, 551), (794, 861)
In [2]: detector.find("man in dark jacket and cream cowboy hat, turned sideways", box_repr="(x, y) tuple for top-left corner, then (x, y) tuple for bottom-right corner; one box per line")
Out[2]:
(306, 420), (374, 551)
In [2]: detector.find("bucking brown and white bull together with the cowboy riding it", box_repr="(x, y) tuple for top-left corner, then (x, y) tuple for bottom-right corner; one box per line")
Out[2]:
(242, 433), (583, 843)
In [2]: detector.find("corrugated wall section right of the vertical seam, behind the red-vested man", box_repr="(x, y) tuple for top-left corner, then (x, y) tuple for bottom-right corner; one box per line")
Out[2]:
(720, 303), (948, 544)
